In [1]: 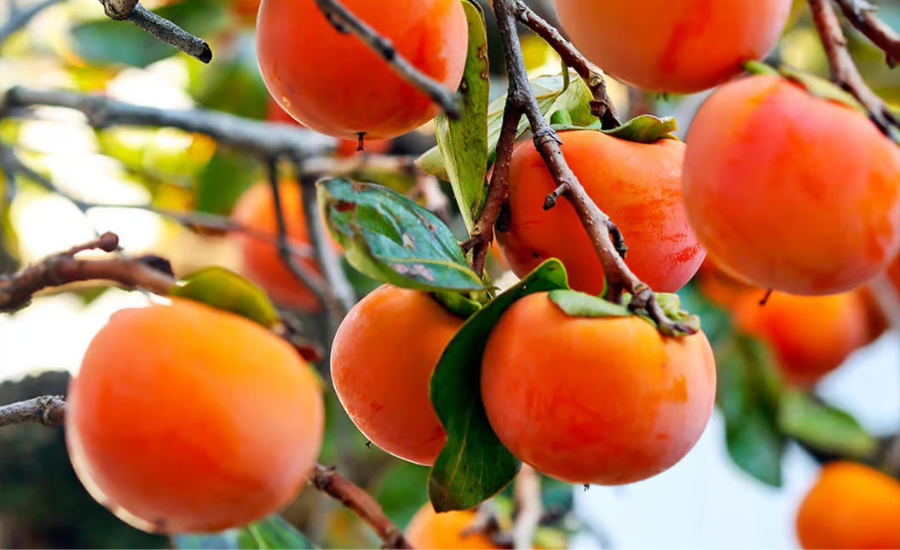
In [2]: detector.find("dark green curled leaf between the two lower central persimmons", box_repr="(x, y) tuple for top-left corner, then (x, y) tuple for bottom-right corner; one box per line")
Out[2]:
(428, 259), (568, 512)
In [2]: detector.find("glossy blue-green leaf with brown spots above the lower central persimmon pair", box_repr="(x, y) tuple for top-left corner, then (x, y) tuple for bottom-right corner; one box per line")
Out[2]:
(318, 179), (484, 292)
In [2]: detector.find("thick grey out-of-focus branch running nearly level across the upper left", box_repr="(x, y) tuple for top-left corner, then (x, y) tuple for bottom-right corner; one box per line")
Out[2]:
(0, 86), (337, 159)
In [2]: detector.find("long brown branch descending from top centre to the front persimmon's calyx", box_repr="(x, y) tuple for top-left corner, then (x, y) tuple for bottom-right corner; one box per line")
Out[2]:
(479, 0), (696, 335)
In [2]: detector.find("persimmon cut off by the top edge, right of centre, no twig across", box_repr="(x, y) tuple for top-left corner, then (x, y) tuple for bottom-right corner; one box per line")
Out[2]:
(556, 0), (791, 93)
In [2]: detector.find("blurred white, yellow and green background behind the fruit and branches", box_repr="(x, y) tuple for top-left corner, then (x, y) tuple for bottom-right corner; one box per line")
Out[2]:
(0, 0), (900, 548)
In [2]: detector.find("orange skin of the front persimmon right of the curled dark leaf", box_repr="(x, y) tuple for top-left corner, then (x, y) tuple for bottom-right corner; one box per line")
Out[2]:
(481, 293), (716, 485)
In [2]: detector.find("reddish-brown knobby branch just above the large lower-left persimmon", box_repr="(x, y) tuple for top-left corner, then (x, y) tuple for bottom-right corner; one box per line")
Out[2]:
(0, 233), (175, 313)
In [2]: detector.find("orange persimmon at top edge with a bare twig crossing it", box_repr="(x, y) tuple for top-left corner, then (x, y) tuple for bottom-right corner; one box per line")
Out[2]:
(257, 0), (468, 139)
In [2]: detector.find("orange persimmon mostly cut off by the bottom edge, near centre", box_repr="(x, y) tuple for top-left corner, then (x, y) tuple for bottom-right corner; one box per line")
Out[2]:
(406, 504), (500, 550)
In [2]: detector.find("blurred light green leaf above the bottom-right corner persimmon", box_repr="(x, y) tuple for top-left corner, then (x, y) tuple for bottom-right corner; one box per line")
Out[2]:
(778, 389), (878, 459)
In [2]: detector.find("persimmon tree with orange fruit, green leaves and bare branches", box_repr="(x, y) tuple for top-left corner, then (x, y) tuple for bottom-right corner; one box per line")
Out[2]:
(0, 0), (900, 548)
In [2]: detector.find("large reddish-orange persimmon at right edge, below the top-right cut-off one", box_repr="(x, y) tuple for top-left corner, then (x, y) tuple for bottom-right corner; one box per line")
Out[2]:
(684, 76), (900, 295)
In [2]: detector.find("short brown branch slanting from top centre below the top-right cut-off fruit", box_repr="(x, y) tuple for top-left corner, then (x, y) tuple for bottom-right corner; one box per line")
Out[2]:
(513, 0), (621, 130)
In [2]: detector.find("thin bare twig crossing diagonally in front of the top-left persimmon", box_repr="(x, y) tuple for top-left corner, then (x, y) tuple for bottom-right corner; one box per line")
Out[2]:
(316, 0), (460, 119)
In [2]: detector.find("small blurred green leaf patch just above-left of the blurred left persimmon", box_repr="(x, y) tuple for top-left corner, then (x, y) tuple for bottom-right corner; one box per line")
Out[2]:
(194, 149), (258, 214)
